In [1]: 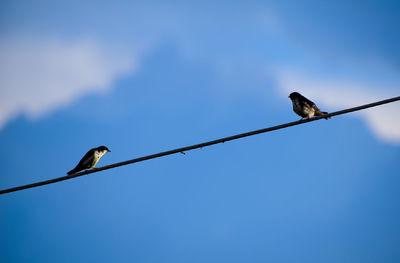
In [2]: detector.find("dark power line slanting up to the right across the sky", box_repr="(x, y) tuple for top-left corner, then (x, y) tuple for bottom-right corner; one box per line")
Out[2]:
(0, 96), (400, 194)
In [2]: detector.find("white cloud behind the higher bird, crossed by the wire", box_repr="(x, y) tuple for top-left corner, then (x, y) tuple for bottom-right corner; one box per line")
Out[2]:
(277, 71), (400, 144)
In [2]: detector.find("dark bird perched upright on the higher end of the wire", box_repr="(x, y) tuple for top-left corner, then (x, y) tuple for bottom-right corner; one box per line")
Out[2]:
(289, 92), (330, 119)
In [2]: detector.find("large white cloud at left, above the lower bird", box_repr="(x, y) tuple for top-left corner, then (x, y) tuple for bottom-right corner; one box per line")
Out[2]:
(0, 38), (137, 128)
